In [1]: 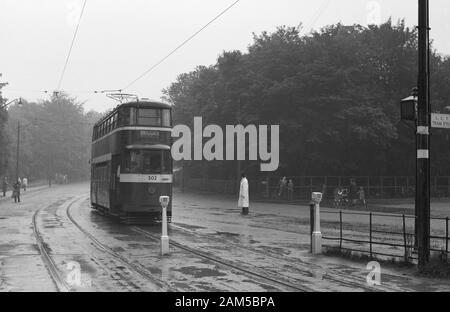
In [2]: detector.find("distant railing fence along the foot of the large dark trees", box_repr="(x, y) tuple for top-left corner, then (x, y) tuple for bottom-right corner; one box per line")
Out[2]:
(185, 176), (450, 200)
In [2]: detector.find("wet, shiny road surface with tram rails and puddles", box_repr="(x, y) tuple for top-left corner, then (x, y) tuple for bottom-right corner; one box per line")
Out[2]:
(0, 184), (450, 291)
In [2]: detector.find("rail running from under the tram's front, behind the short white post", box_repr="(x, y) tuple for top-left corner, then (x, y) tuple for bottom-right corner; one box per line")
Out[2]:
(131, 226), (314, 292)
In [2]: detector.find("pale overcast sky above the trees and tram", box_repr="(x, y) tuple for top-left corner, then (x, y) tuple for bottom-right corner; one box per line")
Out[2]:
(0, 0), (450, 112)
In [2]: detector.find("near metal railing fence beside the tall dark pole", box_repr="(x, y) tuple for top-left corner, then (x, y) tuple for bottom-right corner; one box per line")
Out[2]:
(321, 210), (449, 262)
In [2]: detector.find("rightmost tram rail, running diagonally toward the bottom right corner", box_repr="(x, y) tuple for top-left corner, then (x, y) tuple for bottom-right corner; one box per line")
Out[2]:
(171, 224), (399, 291)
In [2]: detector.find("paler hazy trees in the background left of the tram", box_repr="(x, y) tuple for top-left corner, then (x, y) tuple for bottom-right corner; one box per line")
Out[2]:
(1, 94), (100, 180)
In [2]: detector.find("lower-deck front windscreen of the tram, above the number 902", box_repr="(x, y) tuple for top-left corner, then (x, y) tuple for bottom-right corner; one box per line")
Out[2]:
(121, 150), (172, 173)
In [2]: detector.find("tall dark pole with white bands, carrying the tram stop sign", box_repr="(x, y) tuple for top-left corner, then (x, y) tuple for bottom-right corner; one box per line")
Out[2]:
(416, 0), (431, 270)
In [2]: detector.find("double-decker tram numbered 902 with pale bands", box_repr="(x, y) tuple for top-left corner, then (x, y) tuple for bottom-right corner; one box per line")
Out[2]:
(91, 100), (173, 224)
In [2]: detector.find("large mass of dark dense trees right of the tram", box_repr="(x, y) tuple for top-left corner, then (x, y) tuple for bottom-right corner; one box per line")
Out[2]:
(165, 20), (450, 178)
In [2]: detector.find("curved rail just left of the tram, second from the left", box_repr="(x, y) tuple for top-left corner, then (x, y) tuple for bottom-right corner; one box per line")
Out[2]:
(66, 197), (171, 291)
